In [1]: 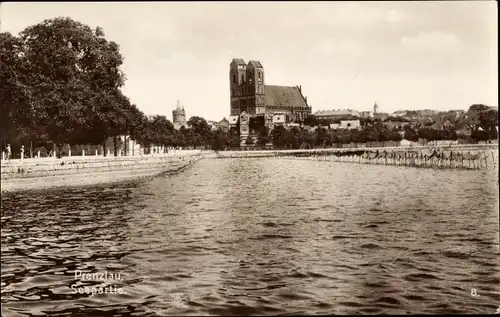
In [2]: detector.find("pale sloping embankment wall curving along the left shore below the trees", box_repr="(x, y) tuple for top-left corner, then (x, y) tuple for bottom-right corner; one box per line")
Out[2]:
(1, 151), (204, 193)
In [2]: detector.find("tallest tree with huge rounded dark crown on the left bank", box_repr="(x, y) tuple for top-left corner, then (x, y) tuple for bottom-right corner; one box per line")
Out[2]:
(15, 18), (125, 153)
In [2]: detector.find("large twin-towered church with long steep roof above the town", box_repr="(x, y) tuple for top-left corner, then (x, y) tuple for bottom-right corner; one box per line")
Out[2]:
(229, 58), (312, 144)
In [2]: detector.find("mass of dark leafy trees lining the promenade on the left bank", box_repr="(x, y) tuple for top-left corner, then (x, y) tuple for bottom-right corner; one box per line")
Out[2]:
(0, 18), (223, 155)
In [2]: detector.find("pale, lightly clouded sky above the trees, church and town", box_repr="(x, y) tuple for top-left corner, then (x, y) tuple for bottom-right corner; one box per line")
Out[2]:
(0, 1), (498, 120)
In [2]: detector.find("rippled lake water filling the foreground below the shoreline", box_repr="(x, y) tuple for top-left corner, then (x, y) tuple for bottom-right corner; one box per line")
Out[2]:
(1, 159), (500, 316)
